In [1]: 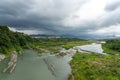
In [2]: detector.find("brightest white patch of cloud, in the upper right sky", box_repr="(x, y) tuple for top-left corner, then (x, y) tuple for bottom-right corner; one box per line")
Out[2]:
(63, 0), (113, 27)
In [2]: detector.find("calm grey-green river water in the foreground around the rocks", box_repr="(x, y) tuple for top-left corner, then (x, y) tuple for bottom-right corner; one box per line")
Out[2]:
(0, 50), (71, 80)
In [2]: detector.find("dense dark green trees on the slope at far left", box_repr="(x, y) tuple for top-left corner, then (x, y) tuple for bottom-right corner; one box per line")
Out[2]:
(0, 25), (33, 55)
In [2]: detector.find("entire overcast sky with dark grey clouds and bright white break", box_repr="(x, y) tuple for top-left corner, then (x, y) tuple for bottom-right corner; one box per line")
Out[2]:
(0, 0), (120, 38)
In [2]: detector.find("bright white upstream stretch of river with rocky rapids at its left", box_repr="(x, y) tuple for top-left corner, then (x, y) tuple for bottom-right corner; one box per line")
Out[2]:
(59, 43), (107, 55)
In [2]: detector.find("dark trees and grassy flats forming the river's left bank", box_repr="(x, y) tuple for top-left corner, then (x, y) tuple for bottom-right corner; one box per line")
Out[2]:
(0, 25), (90, 55)
